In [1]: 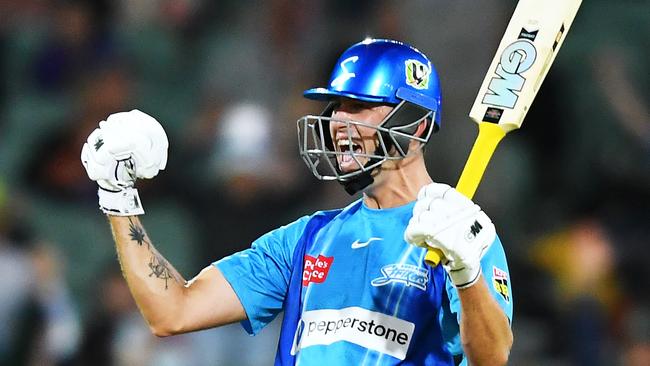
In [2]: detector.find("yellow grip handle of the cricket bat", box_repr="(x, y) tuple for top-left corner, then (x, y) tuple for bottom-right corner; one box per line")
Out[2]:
(424, 122), (506, 267)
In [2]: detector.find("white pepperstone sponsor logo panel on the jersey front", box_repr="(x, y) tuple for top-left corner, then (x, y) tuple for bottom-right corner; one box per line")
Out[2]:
(291, 306), (415, 360)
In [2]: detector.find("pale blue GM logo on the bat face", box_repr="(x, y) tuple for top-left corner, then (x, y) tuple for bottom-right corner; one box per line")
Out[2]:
(483, 28), (538, 109)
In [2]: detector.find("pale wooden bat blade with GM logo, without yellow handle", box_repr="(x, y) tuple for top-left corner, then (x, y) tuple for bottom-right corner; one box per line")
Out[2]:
(469, 0), (582, 132)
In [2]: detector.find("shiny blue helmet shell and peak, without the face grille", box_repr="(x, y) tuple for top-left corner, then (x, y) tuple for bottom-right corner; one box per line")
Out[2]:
(304, 39), (441, 130)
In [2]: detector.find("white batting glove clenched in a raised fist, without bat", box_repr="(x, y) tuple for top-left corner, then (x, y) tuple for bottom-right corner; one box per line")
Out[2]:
(81, 110), (169, 216)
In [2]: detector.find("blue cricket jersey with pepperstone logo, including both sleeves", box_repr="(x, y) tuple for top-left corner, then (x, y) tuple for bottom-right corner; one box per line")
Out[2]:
(215, 200), (512, 365)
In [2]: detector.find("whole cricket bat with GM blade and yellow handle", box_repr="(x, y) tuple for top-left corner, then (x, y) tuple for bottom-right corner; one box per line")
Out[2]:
(424, 0), (582, 266)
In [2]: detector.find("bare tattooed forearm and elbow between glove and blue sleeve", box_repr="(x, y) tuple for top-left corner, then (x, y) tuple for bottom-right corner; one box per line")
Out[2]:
(109, 216), (246, 336)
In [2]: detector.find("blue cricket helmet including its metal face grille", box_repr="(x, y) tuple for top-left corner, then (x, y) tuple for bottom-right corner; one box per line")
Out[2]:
(298, 39), (441, 194)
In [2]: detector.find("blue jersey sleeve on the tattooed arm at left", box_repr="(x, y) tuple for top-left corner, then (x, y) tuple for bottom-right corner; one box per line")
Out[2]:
(213, 216), (309, 334)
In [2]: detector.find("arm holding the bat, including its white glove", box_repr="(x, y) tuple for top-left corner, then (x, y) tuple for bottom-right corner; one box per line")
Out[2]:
(404, 183), (513, 365)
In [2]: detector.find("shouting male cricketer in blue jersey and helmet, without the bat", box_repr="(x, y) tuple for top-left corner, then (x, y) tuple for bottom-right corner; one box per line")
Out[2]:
(81, 39), (513, 365)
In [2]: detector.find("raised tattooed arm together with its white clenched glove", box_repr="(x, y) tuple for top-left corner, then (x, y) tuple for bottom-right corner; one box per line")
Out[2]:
(81, 110), (246, 336)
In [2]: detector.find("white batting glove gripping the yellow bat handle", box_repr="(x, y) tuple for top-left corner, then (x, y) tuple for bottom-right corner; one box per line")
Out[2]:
(404, 183), (496, 288)
